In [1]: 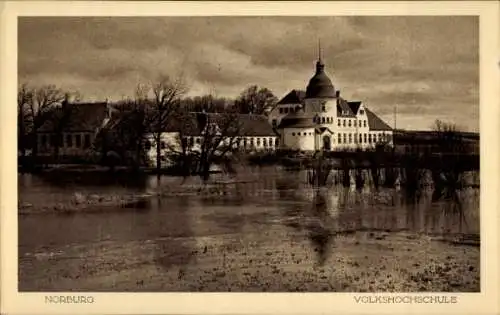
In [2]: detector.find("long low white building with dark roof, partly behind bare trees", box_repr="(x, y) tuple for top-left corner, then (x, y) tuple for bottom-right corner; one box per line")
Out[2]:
(145, 112), (279, 165)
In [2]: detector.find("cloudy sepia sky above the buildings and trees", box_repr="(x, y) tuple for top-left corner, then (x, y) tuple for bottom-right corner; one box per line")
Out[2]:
(18, 17), (479, 131)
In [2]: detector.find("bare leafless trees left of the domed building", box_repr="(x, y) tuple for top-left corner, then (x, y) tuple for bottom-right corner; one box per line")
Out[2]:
(18, 75), (277, 178)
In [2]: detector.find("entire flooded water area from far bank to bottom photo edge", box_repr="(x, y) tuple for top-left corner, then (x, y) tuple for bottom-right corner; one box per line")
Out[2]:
(19, 168), (480, 292)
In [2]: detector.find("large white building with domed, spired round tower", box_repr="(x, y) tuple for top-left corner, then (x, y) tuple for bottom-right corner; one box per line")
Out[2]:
(269, 49), (392, 151)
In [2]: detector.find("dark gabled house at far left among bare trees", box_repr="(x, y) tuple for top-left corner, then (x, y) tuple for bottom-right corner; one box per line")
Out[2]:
(37, 102), (111, 156)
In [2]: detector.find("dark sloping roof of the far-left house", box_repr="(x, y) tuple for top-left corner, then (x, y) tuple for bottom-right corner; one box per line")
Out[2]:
(39, 102), (108, 132)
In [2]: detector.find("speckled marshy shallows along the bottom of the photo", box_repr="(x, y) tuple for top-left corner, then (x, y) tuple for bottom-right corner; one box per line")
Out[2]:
(19, 226), (480, 292)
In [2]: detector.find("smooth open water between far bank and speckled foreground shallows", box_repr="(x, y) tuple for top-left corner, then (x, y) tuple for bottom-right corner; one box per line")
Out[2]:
(18, 169), (479, 290)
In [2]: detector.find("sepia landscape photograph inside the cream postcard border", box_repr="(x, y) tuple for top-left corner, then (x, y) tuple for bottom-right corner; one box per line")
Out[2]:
(17, 15), (483, 293)
